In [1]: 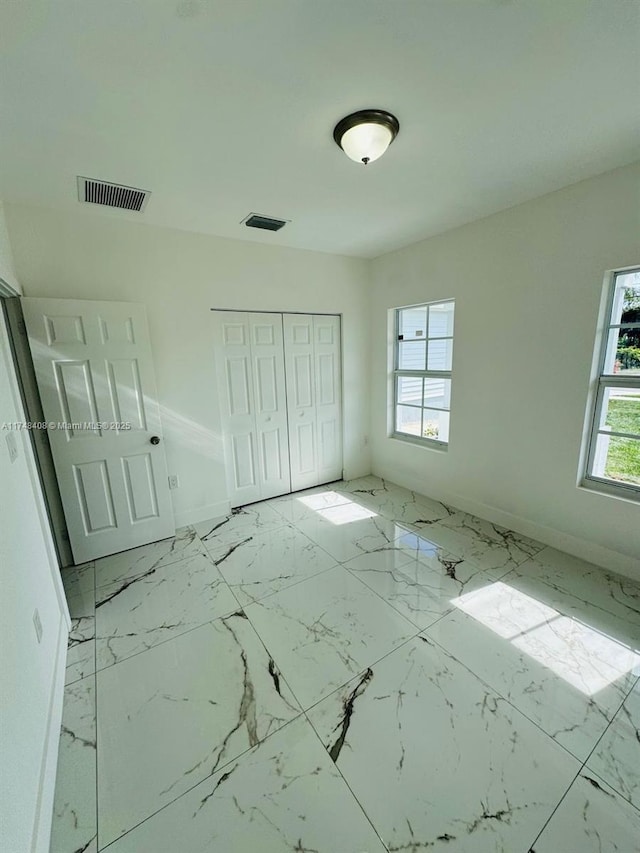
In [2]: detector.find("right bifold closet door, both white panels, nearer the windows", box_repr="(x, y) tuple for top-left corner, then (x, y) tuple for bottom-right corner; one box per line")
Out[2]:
(284, 314), (342, 491)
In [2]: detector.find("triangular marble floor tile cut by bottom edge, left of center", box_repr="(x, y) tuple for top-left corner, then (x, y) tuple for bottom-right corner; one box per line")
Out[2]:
(101, 718), (386, 853)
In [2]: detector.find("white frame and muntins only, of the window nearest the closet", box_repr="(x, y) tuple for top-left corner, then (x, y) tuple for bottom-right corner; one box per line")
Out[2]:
(391, 297), (456, 450)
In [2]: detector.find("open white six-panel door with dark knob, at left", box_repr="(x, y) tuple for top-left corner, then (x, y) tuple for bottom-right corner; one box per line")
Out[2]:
(22, 297), (175, 563)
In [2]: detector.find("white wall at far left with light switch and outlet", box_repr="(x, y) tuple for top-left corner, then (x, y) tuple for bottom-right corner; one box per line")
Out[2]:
(0, 201), (69, 853)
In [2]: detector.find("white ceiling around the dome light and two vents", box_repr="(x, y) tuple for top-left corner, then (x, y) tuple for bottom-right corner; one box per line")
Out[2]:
(0, 0), (640, 257)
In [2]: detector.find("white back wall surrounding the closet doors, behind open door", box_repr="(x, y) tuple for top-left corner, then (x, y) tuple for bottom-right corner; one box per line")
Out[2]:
(7, 205), (370, 525)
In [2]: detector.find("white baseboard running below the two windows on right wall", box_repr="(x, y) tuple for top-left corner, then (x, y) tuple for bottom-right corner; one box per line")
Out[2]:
(373, 468), (640, 581)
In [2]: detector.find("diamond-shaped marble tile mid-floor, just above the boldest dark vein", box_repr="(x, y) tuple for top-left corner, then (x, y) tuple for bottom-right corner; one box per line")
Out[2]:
(246, 566), (417, 708)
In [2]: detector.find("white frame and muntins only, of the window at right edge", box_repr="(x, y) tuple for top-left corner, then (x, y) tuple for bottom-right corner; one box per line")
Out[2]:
(582, 266), (640, 501)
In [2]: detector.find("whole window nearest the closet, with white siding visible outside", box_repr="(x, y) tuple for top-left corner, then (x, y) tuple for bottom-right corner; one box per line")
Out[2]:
(394, 300), (454, 446)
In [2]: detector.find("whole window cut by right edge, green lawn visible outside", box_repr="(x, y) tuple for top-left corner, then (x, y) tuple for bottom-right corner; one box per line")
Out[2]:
(586, 268), (640, 498)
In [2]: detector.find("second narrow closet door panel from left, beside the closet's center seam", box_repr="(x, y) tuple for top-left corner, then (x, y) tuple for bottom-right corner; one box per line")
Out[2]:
(249, 314), (291, 500)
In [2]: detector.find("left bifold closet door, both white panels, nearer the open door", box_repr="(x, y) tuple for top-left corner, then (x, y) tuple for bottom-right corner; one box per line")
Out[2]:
(213, 311), (291, 506)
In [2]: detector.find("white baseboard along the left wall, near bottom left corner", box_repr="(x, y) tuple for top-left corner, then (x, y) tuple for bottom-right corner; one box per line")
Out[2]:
(31, 614), (68, 853)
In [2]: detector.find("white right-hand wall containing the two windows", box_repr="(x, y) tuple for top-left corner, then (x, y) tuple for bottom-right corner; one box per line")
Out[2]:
(371, 164), (640, 578)
